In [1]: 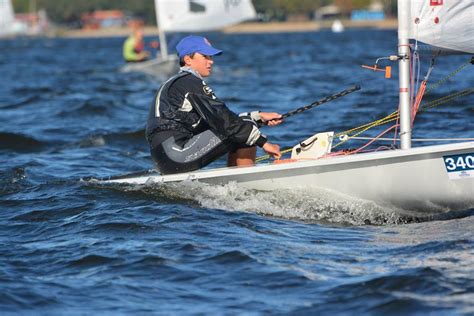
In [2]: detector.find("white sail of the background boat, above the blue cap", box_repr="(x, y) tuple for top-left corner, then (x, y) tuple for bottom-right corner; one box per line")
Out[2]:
(155, 0), (256, 32)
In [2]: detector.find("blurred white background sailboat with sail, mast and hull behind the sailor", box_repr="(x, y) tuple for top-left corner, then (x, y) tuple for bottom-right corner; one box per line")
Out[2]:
(123, 0), (257, 74)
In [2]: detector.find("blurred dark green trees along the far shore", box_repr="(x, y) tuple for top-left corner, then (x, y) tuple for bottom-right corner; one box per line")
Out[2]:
(12, 0), (382, 24)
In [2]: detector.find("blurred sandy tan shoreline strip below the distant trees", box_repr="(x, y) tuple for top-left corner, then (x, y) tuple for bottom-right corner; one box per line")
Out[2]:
(55, 19), (398, 38)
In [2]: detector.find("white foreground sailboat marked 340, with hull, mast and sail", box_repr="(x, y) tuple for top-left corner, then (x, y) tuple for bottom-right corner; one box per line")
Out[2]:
(108, 0), (474, 214)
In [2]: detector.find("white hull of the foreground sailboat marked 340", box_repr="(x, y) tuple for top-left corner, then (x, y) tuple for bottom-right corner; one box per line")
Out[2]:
(104, 142), (474, 210)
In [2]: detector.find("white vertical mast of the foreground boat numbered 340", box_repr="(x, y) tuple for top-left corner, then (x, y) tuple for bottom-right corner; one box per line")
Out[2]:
(398, 0), (411, 149)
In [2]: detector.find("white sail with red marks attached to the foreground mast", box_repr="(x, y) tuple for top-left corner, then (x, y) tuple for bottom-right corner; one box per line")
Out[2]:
(404, 0), (474, 54)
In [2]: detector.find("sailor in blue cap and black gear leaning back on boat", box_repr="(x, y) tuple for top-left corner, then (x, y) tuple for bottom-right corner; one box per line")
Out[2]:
(146, 35), (282, 174)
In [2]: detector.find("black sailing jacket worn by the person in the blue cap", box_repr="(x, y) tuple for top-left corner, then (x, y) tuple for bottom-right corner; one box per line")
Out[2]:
(146, 71), (266, 146)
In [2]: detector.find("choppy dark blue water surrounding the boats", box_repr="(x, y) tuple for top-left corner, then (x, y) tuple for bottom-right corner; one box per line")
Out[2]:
(0, 30), (474, 315)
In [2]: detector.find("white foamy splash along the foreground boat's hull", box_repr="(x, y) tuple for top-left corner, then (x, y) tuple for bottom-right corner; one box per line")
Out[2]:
(113, 181), (413, 225)
